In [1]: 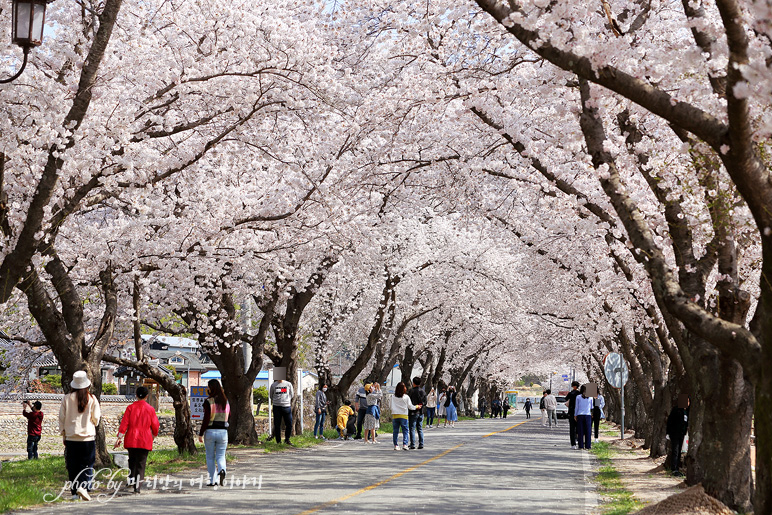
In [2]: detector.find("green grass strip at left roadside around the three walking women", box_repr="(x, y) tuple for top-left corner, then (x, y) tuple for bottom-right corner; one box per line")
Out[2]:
(0, 446), (222, 513)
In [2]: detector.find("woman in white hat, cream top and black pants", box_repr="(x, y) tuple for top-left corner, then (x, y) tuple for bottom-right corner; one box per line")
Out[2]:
(59, 370), (102, 501)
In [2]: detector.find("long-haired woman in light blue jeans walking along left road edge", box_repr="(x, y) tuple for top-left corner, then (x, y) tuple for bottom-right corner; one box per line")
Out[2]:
(198, 379), (231, 486)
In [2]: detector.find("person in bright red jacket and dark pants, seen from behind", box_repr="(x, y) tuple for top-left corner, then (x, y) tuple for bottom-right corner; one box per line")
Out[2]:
(113, 386), (159, 494)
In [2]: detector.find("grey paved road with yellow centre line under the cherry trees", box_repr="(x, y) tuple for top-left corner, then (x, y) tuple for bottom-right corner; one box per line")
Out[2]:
(25, 414), (597, 515)
